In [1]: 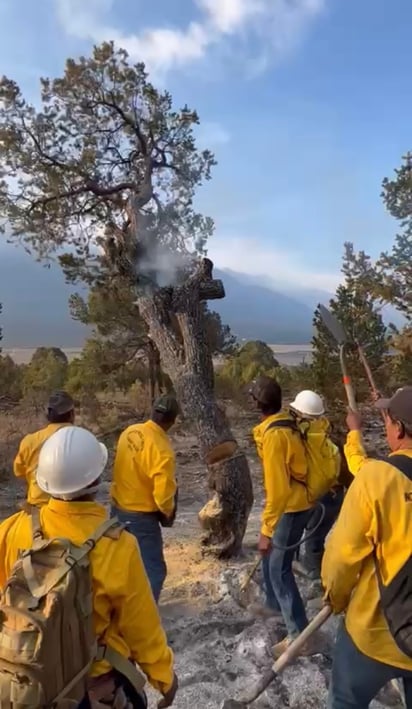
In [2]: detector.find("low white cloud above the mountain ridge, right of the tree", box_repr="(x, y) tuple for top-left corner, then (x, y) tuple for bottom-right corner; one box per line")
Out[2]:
(208, 236), (342, 293)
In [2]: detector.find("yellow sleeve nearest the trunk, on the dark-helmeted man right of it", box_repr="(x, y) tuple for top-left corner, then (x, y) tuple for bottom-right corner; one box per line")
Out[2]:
(261, 431), (290, 537)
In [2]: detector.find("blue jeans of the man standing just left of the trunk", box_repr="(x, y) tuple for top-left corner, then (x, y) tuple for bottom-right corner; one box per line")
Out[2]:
(112, 506), (167, 603)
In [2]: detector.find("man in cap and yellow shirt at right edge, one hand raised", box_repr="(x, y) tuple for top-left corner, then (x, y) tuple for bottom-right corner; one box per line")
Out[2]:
(322, 386), (412, 709)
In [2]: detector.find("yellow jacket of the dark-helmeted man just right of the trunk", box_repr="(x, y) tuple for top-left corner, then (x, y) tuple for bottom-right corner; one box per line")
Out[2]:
(253, 413), (311, 537)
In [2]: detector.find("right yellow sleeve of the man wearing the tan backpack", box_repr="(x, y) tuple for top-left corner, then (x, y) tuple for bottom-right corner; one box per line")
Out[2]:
(113, 532), (174, 694)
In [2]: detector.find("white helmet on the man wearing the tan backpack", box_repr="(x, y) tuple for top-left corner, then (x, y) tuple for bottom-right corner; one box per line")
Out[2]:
(36, 426), (108, 500)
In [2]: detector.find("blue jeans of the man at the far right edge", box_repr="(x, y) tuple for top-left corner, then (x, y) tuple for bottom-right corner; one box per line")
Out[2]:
(328, 621), (412, 709)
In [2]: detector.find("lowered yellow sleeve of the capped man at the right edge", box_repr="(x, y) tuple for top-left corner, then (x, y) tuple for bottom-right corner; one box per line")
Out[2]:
(321, 466), (376, 613)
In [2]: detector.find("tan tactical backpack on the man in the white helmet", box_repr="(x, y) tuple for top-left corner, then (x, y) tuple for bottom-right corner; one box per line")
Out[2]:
(0, 508), (144, 709)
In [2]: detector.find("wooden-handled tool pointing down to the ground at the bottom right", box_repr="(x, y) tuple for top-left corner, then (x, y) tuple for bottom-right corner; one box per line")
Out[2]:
(221, 606), (332, 709)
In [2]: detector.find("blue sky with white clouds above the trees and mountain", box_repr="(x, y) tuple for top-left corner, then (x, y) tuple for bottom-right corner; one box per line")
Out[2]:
(0, 0), (412, 290)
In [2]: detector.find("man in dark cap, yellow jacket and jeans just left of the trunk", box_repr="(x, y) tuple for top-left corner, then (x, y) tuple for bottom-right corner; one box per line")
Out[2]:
(111, 395), (179, 601)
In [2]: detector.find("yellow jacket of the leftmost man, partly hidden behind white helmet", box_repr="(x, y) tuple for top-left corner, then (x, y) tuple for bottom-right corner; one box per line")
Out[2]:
(13, 423), (68, 505)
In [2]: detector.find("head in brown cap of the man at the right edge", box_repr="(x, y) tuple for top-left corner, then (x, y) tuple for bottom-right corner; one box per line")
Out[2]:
(375, 386), (412, 451)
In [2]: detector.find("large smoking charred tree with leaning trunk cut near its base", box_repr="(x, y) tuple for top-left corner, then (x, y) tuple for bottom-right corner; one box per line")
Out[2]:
(0, 43), (253, 556)
